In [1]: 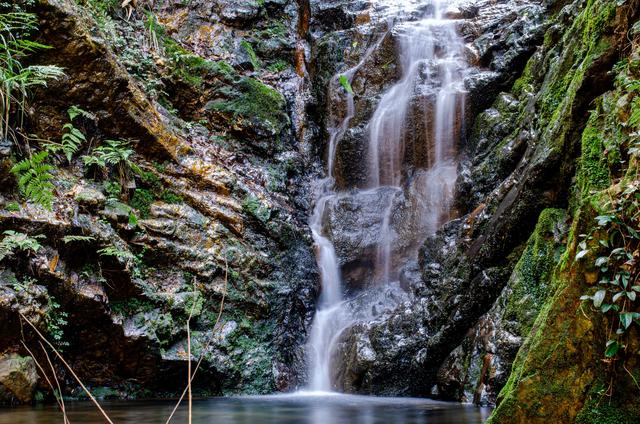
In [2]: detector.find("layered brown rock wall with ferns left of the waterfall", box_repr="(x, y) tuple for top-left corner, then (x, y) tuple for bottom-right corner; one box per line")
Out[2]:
(0, 0), (318, 402)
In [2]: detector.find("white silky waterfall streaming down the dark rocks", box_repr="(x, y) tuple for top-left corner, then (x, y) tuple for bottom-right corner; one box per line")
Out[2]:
(308, 0), (467, 391)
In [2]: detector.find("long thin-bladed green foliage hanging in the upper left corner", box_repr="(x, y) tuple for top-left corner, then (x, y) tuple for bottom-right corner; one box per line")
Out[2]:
(0, 12), (63, 138)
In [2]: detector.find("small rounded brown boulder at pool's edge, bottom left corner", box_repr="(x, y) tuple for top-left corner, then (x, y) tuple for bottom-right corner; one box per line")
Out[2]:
(0, 354), (38, 404)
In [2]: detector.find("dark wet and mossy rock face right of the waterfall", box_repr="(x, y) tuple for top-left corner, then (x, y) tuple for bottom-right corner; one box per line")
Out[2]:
(308, 1), (639, 423)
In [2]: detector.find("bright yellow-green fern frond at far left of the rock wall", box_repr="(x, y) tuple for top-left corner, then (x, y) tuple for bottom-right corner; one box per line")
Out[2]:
(11, 151), (55, 210)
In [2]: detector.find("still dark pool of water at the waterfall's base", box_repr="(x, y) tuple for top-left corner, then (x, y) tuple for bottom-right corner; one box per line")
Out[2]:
(0, 393), (489, 424)
